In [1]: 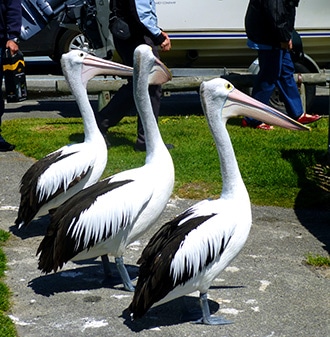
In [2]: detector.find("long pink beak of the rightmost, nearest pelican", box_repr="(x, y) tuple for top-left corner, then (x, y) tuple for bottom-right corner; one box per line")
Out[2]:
(223, 88), (310, 131)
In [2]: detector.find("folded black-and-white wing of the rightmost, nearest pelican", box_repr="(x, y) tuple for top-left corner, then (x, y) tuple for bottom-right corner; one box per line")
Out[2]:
(130, 208), (225, 318)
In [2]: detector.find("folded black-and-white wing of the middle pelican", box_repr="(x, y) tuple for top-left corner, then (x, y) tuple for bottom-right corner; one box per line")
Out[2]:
(37, 177), (152, 273)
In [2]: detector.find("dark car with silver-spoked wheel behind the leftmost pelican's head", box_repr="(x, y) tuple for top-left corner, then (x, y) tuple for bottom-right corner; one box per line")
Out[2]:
(20, 0), (98, 62)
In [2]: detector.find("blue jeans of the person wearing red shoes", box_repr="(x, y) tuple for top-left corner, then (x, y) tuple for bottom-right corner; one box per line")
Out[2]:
(246, 49), (304, 126)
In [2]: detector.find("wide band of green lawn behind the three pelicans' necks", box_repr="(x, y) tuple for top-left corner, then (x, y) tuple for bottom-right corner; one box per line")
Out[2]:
(3, 116), (330, 208)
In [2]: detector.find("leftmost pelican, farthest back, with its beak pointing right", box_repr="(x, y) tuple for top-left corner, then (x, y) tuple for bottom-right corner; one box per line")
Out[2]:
(15, 50), (133, 228)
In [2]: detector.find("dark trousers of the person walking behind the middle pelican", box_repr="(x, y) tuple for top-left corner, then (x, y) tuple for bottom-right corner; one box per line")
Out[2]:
(97, 37), (162, 144)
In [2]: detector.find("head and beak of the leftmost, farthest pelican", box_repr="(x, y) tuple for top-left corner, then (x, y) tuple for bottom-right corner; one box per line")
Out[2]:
(61, 50), (133, 87)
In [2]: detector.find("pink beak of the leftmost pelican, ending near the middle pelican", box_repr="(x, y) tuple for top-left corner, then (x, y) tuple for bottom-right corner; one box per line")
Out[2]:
(81, 54), (133, 86)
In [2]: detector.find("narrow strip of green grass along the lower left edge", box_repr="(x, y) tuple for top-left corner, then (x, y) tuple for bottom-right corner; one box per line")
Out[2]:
(0, 229), (16, 337)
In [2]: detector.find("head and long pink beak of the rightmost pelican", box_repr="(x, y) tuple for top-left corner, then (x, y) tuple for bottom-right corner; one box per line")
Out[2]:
(200, 78), (309, 130)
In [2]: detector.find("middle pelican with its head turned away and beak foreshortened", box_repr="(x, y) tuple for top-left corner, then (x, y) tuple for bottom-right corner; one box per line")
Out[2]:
(37, 45), (174, 291)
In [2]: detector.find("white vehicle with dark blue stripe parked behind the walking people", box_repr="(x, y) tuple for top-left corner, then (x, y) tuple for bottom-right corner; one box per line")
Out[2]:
(156, 0), (330, 72)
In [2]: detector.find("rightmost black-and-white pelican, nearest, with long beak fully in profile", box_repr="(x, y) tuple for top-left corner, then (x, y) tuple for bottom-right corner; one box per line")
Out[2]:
(128, 78), (305, 324)
